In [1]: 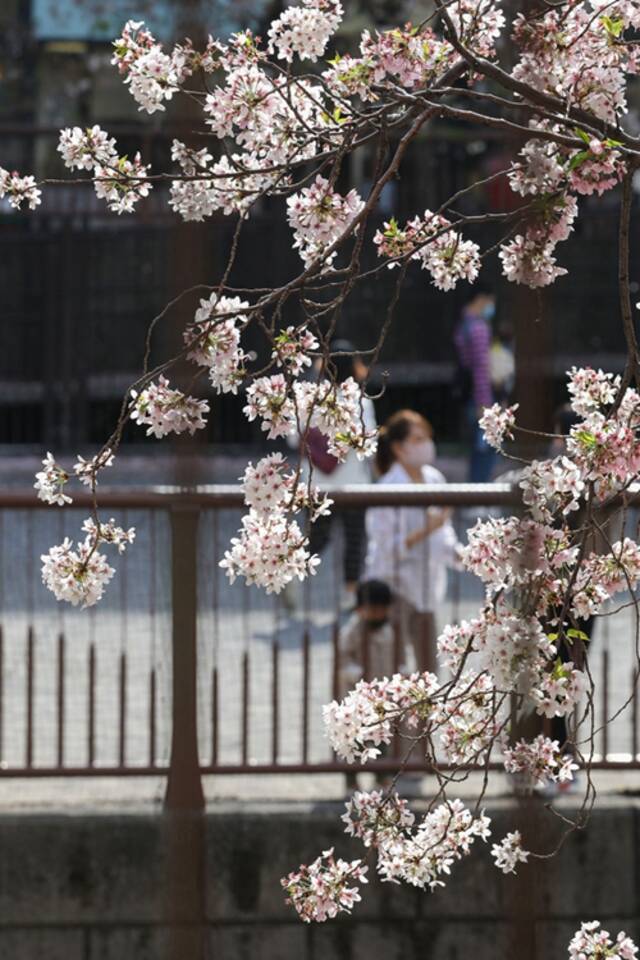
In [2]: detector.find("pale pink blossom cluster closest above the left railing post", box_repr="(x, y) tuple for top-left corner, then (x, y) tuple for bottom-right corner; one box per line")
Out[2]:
(129, 376), (209, 437)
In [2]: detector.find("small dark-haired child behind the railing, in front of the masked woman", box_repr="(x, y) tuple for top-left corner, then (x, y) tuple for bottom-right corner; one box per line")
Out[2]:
(338, 580), (406, 790)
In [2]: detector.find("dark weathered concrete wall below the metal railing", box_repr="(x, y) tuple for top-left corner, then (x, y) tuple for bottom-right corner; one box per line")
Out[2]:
(0, 801), (640, 960)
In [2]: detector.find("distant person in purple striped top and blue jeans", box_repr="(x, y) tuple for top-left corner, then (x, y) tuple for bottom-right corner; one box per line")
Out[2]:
(454, 283), (496, 483)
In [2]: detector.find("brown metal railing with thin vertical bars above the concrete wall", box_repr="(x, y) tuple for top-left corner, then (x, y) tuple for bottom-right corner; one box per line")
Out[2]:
(0, 484), (640, 806)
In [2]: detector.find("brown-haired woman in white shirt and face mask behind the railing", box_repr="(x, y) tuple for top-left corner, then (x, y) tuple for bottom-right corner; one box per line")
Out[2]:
(365, 410), (458, 672)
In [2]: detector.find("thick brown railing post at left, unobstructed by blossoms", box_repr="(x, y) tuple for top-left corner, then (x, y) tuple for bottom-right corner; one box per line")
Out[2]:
(165, 502), (206, 960)
